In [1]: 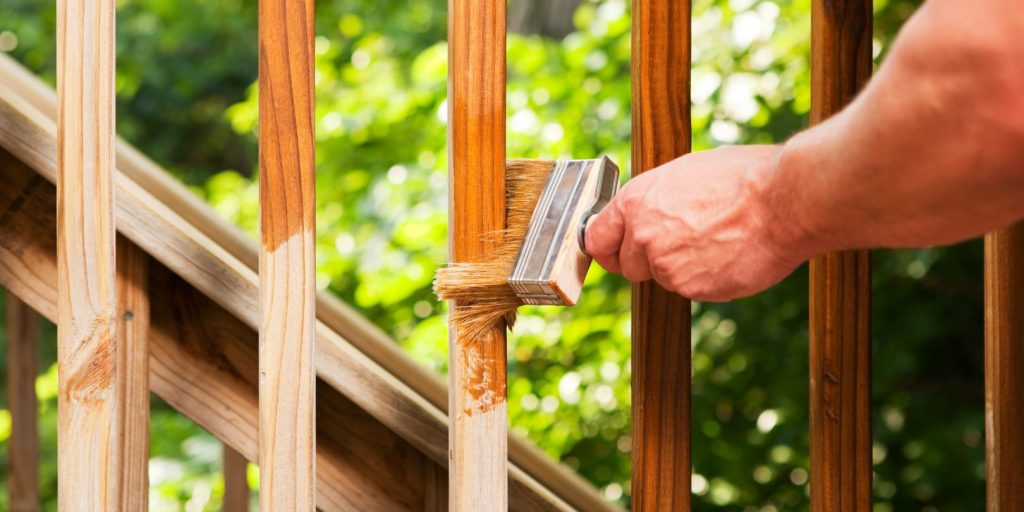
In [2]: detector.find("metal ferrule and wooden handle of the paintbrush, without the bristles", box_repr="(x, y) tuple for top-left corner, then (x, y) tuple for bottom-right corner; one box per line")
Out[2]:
(509, 157), (618, 305)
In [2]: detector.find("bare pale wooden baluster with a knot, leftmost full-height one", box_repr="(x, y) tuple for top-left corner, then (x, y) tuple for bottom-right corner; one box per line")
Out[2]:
(56, 0), (122, 505)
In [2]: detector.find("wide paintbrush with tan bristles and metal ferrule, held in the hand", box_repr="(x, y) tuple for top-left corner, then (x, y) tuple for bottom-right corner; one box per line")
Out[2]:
(434, 157), (618, 338)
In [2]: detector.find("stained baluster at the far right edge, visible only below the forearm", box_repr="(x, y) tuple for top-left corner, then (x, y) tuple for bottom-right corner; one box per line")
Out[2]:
(985, 224), (1024, 512)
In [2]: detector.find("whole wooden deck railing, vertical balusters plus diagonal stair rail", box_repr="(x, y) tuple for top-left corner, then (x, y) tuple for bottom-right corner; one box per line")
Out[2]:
(0, 0), (1024, 512)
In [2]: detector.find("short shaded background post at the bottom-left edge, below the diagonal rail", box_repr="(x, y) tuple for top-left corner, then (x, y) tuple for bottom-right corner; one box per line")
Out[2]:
(7, 293), (39, 512)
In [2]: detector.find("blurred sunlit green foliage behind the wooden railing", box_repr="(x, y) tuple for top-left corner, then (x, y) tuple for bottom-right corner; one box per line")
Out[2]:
(0, 0), (984, 512)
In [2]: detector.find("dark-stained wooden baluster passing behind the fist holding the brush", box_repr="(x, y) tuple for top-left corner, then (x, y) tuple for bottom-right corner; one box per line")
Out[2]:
(632, 0), (691, 511)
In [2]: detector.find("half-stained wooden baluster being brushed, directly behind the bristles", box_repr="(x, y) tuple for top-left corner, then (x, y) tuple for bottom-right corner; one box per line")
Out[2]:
(447, 0), (508, 511)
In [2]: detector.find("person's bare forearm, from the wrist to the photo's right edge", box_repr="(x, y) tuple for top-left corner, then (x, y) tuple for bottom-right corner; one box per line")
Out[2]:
(764, 0), (1024, 256)
